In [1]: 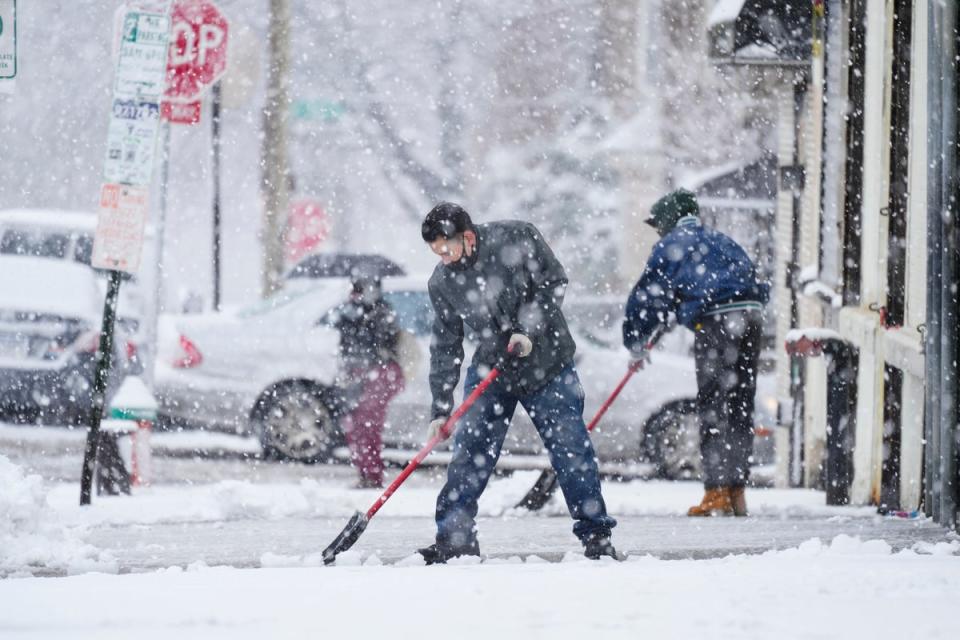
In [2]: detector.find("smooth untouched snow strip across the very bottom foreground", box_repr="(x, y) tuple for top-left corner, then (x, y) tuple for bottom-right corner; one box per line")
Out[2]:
(0, 538), (960, 640)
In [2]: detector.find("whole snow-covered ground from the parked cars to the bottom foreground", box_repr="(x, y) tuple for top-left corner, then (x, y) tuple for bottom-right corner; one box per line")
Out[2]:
(0, 426), (960, 638)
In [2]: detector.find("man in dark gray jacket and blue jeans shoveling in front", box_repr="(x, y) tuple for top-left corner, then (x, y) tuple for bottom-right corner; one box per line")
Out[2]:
(420, 202), (616, 564)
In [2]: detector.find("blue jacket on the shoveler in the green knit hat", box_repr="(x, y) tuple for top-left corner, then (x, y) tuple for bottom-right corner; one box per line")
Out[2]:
(623, 216), (770, 349)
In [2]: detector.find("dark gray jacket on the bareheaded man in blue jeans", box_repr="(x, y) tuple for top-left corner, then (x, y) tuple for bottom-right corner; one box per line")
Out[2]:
(428, 221), (576, 418)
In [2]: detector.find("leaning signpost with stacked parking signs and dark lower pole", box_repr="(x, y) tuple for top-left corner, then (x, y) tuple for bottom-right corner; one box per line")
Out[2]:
(80, 3), (170, 505)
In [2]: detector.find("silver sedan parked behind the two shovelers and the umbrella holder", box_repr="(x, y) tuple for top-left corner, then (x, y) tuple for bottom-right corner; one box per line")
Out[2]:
(156, 277), (772, 478)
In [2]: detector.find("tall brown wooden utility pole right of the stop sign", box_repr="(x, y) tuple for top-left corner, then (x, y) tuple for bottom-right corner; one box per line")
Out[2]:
(261, 0), (290, 296)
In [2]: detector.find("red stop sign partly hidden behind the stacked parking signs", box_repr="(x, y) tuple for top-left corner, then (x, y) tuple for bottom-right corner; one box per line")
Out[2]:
(163, 0), (227, 102)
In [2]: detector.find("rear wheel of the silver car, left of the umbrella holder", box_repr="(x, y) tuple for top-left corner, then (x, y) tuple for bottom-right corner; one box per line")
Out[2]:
(251, 380), (344, 463)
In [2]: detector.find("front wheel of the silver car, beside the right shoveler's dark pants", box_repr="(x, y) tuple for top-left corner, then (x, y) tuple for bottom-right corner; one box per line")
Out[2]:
(640, 399), (703, 480)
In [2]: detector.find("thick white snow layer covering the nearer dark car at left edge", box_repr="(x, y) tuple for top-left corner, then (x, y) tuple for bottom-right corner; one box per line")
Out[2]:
(0, 256), (103, 323)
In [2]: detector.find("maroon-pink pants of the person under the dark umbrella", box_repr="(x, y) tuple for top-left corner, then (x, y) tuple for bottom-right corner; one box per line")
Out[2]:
(342, 362), (403, 484)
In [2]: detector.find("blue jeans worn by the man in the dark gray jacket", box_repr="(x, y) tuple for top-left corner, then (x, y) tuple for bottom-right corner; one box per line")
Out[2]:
(437, 363), (617, 547)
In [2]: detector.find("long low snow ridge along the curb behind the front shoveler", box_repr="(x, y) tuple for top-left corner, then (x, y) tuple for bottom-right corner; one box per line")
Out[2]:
(39, 471), (875, 528)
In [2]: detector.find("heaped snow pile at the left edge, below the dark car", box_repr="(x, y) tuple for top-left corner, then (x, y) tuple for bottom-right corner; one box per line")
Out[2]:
(0, 455), (116, 575)
